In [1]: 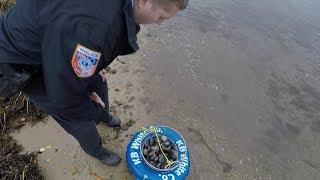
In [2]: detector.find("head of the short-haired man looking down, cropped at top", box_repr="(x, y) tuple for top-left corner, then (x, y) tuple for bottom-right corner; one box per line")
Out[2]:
(134, 0), (189, 24)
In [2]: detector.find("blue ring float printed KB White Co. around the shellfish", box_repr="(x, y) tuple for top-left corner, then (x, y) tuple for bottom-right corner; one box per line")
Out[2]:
(126, 126), (190, 180)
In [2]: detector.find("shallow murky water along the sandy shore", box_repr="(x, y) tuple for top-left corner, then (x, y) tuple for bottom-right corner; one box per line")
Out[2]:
(139, 0), (320, 179)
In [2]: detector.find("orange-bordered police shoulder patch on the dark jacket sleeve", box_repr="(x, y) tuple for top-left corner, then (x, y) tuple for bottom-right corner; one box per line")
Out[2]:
(71, 44), (101, 78)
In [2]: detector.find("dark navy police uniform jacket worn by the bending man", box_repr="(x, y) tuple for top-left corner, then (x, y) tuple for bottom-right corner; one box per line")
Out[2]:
(0, 0), (140, 120)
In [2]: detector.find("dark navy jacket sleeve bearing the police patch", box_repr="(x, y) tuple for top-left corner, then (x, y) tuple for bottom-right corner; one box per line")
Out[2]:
(41, 17), (112, 120)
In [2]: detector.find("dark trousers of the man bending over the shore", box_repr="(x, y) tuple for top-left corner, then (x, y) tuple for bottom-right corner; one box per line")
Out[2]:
(23, 74), (109, 157)
